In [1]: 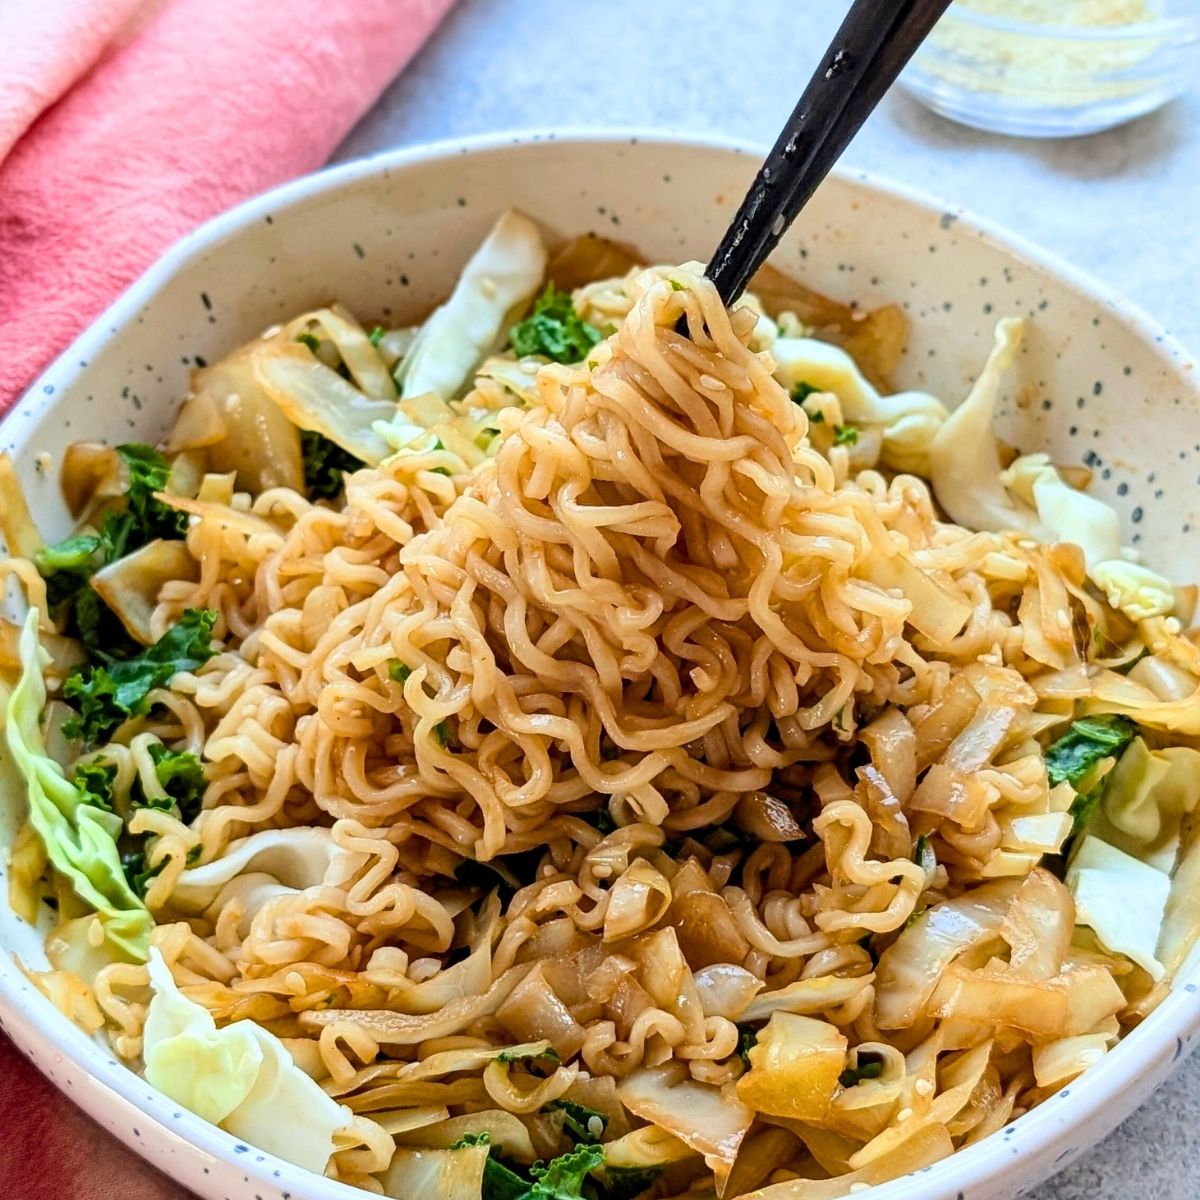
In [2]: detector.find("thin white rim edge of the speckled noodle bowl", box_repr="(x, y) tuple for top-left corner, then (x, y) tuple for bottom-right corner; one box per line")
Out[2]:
(0, 126), (1200, 1200)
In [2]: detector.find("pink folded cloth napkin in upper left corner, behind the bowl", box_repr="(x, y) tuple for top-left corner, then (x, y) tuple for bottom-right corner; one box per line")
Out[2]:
(0, 0), (452, 414)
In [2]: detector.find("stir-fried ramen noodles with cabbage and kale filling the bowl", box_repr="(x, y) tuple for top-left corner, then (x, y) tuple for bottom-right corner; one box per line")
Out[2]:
(0, 212), (1200, 1200)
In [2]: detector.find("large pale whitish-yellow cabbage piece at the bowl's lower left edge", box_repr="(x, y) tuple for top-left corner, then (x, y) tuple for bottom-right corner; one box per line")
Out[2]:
(142, 949), (350, 1175)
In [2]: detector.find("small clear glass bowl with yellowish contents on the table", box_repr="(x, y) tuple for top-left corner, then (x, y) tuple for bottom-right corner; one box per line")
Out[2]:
(900, 0), (1200, 138)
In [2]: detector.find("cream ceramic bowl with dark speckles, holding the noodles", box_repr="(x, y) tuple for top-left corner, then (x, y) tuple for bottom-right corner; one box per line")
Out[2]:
(0, 132), (1200, 1200)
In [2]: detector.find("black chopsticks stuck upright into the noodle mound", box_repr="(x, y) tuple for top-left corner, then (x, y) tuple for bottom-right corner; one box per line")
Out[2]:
(704, 0), (950, 306)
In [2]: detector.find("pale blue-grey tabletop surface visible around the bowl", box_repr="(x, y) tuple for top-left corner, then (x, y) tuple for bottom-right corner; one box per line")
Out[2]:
(337, 0), (1200, 1200)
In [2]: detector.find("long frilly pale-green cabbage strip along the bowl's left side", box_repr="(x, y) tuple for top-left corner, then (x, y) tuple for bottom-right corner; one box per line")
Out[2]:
(5, 608), (152, 962)
